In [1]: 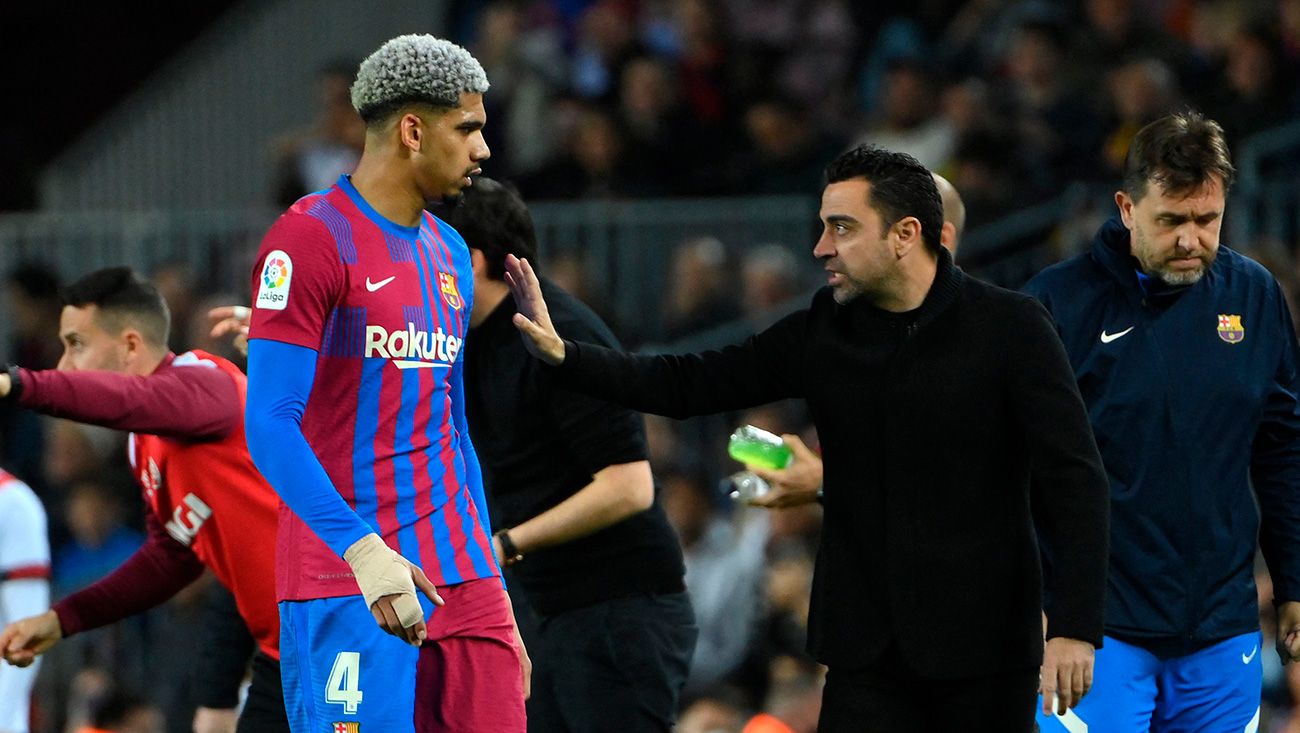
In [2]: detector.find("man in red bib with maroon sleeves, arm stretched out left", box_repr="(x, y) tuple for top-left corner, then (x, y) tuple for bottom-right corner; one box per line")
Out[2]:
(0, 268), (289, 733)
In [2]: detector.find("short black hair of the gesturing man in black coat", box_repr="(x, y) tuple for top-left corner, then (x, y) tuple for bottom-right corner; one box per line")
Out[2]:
(826, 146), (944, 252)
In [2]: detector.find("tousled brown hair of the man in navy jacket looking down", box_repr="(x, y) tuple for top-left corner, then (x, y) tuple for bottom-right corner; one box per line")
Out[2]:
(1123, 109), (1236, 201)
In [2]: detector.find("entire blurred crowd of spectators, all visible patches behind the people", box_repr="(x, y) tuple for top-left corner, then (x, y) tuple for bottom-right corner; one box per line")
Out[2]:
(0, 0), (1300, 733)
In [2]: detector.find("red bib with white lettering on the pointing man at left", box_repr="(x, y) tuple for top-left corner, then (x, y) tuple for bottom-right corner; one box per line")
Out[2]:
(127, 351), (280, 659)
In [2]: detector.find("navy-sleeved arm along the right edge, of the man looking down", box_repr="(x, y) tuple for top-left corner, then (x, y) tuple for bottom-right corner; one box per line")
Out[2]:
(1251, 285), (1300, 663)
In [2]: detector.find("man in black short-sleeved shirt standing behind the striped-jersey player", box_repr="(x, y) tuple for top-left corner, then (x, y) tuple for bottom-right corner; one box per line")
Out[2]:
(446, 178), (698, 733)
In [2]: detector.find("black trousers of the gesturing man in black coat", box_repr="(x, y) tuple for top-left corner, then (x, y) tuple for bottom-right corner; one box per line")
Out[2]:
(818, 642), (1039, 733)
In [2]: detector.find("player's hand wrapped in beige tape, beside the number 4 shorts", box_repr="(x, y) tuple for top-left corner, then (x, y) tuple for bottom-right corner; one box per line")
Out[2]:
(343, 533), (443, 646)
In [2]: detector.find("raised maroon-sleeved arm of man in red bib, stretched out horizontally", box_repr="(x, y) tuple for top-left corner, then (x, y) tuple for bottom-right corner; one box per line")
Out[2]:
(0, 363), (242, 439)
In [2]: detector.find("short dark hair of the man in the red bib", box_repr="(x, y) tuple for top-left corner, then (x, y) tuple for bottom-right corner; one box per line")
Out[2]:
(61, 268), (172, 347)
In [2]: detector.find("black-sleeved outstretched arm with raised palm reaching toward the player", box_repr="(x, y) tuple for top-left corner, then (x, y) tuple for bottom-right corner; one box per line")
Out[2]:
(506, 255), (806, 418)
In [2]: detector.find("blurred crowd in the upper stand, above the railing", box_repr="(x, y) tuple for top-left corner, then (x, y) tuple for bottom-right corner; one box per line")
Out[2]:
(441, 0), (1300, 221)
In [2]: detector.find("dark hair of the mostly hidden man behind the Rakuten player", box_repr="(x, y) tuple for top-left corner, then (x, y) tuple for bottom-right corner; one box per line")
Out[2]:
(447, 175), (537, 279)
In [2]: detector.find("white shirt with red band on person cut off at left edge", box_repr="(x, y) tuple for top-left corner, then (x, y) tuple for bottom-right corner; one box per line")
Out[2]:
(0, 470), (49, 733)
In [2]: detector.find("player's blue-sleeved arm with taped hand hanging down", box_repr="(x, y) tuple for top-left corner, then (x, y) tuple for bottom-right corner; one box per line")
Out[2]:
(244, 338), (444, 645)
